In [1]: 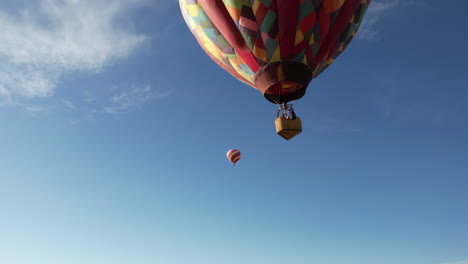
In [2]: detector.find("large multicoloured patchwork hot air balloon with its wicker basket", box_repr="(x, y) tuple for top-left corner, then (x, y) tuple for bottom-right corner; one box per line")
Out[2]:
(179, 0), (371, 139)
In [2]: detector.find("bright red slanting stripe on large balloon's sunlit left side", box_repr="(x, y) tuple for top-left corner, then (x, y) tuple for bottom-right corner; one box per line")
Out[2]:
(198, 0), (260, 72)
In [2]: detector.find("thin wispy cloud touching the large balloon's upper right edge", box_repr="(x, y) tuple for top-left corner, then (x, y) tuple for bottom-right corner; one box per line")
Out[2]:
(357, 0), (424, 40)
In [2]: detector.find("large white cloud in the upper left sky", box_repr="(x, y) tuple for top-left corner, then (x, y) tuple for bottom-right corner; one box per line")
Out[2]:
(0, 0), (146, 104)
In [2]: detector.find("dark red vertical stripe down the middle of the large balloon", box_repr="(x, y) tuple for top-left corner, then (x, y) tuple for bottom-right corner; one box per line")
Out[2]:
(276, 0), (300, 60)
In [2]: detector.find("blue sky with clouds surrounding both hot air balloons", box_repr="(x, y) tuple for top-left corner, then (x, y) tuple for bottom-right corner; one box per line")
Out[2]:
(0, 0), (468, 264)
